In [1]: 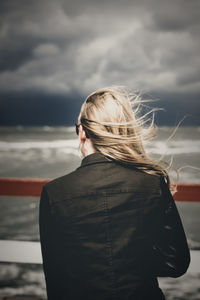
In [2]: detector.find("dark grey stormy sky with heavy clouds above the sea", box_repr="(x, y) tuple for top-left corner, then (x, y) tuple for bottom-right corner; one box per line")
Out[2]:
(0, 0), (200, 124)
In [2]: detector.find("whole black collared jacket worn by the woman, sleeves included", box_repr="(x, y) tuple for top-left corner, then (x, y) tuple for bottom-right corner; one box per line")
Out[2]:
(39, 152), (190, 300)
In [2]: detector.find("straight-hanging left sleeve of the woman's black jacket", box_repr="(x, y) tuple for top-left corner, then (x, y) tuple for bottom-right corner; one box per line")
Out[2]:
(39, 186), (63, 300)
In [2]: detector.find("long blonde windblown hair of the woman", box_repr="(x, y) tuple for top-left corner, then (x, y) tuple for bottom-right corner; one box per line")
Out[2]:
(78, 87), (173, 190)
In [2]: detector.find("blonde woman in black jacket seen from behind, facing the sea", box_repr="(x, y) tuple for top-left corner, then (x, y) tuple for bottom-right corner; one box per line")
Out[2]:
(39, 88), (190, 300)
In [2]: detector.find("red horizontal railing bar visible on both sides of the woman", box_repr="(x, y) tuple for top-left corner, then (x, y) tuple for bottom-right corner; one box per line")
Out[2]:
(0, 178), (200, 202)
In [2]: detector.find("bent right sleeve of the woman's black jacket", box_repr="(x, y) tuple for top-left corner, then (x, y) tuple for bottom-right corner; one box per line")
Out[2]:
(150, 178), (190, 278)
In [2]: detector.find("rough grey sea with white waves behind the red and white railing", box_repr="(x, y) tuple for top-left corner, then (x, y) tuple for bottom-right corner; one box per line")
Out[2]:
(0, 126), (200, 300)
